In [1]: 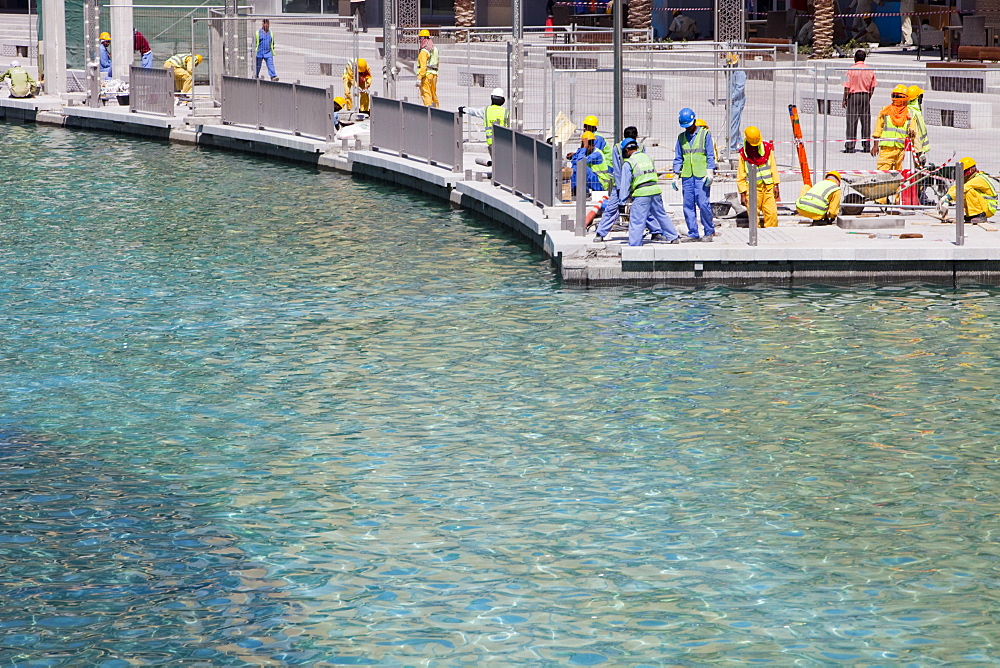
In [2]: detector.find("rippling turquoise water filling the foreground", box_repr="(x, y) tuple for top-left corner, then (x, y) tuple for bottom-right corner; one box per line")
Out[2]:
(0, 126), (1000, 666)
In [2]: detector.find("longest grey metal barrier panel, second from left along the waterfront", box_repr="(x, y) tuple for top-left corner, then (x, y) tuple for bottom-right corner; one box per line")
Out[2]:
(222, 76), (335, 141)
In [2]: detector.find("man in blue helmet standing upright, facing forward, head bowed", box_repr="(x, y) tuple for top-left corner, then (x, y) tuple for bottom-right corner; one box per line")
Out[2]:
(671, 107), (715, 241)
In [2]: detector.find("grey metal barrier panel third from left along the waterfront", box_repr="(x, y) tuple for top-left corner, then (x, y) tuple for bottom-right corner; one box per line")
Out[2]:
(371, 97), (463, 172)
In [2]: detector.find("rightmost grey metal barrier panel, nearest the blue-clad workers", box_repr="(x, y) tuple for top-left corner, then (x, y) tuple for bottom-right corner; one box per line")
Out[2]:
(493, 125), (556, 206)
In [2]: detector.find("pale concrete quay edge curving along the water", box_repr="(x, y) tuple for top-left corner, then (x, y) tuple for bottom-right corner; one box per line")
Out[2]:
(0, 51), (1000, 286)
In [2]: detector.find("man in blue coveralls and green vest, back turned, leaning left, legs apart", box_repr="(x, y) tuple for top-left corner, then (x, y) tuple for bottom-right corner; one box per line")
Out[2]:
(608, 138), (680, 246)
